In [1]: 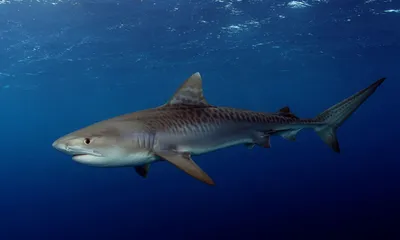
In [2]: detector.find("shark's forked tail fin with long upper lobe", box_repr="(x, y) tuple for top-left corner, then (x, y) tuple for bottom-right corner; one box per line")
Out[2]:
(314, 78), (386, 152)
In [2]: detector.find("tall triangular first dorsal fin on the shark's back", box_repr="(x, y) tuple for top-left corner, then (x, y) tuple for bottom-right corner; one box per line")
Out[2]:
(165, 72), (209, 106)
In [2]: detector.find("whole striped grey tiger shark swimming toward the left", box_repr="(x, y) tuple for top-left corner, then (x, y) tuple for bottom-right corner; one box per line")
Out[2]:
(52, 72), (385, 185)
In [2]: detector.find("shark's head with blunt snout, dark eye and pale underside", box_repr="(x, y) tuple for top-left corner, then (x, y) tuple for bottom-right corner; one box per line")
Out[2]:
(53, 123), (133, 166)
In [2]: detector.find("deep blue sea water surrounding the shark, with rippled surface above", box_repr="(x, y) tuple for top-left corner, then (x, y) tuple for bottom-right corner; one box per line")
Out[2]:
(0, 0), (400, 240)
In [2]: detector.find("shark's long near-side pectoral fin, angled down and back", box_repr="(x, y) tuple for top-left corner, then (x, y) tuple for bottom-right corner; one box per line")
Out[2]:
(156, 151), (215, 185)
